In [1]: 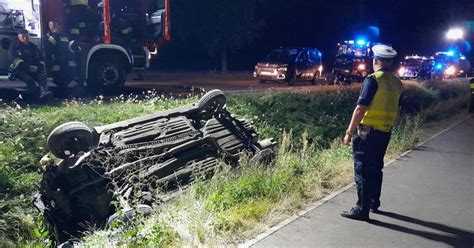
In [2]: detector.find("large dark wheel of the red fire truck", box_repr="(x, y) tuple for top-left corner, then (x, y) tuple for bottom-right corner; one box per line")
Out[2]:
(88, 56), (126, 94)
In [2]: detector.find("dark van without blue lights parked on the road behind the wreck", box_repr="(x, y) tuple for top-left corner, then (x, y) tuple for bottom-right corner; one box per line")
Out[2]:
(253, 47), (323, 85)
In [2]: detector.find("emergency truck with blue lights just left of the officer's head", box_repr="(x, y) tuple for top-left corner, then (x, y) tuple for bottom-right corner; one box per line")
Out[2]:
(332, 39), (372, 83)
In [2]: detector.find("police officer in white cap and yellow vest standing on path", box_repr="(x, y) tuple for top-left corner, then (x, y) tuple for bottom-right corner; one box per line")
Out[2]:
(341, 45), (403, 221)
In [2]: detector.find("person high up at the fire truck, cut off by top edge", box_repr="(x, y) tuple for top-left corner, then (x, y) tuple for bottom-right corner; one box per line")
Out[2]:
(64, 0), (89, 39)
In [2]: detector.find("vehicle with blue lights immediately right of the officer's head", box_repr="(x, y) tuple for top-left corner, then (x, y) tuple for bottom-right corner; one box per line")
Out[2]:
(398, 55), (434, 79)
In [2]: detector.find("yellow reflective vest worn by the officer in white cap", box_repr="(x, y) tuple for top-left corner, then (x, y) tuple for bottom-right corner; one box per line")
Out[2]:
(361, 71), (403, 132)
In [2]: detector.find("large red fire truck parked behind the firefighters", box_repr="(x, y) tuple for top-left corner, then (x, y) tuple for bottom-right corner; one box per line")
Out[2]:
(0, 0), (170, 94)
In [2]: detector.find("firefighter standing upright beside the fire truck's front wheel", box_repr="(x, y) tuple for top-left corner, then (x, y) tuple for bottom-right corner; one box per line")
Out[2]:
(45, 21), (79, 97)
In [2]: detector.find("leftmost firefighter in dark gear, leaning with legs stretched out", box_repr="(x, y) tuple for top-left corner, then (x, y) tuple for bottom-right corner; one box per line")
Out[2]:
(8, 29), (51, 99)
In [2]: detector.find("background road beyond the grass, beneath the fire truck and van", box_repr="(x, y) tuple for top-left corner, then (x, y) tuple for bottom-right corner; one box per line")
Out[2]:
(0, 72), (348, 102)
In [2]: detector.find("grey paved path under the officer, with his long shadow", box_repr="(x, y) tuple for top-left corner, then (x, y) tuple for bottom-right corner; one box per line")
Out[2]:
(253, 116), (474, 248)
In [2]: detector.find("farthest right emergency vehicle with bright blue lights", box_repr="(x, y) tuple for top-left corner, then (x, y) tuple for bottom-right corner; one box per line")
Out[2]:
(431, 50), (471, 79)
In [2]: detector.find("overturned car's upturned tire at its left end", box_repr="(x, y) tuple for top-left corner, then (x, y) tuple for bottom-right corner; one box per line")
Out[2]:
(47, 122), (94, 159)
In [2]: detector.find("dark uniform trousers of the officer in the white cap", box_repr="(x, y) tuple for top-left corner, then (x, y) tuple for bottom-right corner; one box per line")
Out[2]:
(352, 127), (391, 215)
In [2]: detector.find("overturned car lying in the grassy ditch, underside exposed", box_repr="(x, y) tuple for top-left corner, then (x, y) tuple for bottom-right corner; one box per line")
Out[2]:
(35, 90), (275, 242)
